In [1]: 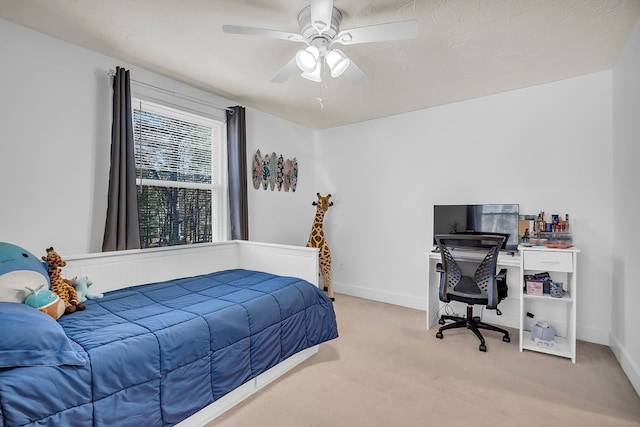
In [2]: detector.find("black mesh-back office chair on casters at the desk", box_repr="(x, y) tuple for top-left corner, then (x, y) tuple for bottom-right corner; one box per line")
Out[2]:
(435, 234), (511, 351)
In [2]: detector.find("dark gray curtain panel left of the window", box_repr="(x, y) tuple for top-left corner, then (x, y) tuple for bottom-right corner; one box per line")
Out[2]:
(102, 67), (140, 252)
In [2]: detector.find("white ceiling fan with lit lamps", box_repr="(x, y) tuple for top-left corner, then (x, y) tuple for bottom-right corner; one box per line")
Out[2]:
(222, 0), (418, 84)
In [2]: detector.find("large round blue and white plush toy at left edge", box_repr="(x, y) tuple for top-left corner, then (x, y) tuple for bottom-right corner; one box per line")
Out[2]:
(0, 242), (49, 304)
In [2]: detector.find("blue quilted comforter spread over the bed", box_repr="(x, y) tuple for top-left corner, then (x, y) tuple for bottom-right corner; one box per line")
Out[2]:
(0, 270), (338, 426)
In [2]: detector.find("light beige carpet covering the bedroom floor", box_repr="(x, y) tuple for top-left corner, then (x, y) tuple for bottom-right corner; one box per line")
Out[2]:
(208, 295), (640, 427)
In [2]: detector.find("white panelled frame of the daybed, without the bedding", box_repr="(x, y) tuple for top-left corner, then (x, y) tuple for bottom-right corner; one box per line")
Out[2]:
(63, 240), (318, 427)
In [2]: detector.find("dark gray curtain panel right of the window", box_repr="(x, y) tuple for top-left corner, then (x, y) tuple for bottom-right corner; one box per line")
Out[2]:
(227, 106), (249, 240)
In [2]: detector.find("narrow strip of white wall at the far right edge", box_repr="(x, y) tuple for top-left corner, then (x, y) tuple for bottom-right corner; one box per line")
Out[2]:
(611, 18), (640, 394)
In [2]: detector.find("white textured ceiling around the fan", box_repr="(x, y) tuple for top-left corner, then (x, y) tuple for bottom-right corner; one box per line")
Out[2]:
(0, 0), (640, 129)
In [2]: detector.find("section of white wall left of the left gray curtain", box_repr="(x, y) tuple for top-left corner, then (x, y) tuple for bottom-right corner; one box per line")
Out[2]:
(0, 20), (111, 254)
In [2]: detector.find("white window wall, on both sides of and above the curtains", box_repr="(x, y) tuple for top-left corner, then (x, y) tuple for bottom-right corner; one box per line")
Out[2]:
(0, 19), (315, 255)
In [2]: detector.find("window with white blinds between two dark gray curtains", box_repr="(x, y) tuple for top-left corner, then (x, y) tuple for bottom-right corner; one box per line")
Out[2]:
(132, 99), (227, 248)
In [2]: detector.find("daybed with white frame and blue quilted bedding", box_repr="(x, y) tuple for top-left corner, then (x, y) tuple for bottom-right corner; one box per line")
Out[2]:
(0, 241), (338, 427)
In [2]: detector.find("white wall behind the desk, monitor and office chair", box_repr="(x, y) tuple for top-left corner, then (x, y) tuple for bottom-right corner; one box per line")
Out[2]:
(316, 71), (613, 344)
